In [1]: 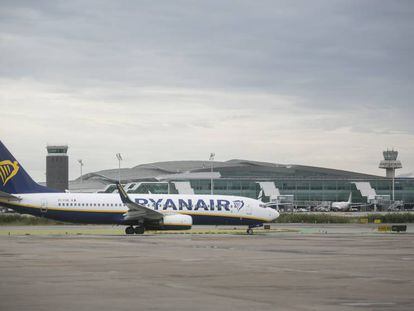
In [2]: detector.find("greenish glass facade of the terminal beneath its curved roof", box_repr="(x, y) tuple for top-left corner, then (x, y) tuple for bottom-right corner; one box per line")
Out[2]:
(124, 177), (414, 204)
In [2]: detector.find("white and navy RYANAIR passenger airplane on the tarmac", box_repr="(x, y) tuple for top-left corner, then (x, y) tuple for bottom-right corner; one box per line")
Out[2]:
(0, 141), (279, 234)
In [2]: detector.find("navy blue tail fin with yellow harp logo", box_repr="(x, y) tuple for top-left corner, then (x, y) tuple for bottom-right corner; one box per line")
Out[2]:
(0, 141), (57, 193)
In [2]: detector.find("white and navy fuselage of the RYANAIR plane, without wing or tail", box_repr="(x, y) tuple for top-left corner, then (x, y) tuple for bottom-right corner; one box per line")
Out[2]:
(4, 193), (279, 224)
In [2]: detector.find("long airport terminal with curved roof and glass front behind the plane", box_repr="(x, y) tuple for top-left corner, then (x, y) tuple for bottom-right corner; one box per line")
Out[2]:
(69, 160), (414, 208)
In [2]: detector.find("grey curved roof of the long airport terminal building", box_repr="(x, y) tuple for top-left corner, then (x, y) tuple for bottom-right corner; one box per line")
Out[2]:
(74, 159), (380, 184)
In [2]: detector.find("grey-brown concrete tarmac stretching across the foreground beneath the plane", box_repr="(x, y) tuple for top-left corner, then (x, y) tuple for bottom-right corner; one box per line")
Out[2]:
(0, 224), (414, 311)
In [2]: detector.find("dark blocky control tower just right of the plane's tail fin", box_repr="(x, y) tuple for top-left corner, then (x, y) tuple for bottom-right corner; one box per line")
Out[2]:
(46, 145), (69, 191)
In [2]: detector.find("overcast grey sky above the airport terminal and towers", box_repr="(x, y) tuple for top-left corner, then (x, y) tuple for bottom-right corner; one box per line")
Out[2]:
(0, 0), (414, 181)
